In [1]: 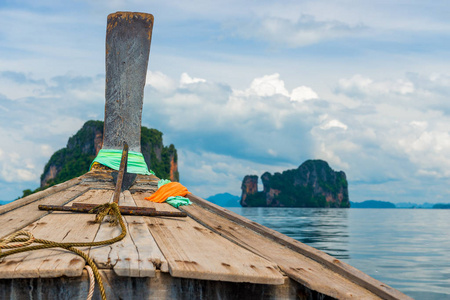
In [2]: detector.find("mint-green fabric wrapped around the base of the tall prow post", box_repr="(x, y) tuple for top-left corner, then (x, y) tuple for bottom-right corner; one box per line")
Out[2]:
(89, 149), (155, 175)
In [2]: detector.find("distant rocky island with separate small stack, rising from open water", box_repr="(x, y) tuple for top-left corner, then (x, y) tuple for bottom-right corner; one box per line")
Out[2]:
(241, 160), (350, 208)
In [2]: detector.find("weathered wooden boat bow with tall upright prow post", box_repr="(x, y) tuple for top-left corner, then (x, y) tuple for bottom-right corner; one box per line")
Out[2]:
(0, 13), (410, 299)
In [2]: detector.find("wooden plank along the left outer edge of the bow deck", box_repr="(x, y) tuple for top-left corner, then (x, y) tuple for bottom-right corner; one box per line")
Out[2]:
(0, 185), (89, 237)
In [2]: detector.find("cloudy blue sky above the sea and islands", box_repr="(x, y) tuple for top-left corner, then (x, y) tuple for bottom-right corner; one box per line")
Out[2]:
(0, 0), (450, 203)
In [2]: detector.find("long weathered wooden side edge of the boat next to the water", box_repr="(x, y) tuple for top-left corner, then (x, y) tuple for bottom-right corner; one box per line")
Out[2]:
(182, 194), (411, 299)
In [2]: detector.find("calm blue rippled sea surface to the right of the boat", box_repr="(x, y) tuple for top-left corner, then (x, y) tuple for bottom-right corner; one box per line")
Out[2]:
(228, 207), (450, 300)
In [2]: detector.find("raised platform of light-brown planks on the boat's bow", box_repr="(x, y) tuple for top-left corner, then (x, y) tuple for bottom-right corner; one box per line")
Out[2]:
(0, 172), (286, 285)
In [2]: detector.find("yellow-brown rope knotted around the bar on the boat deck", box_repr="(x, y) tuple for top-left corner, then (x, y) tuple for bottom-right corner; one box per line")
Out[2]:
(0, 202), (127, 300)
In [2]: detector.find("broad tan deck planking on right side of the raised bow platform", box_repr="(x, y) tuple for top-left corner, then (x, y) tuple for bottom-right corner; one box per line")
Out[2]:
(134, 193), (285, 284)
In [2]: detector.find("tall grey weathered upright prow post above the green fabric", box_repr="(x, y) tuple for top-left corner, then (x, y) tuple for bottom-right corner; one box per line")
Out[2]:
(102, 12), (153, 152)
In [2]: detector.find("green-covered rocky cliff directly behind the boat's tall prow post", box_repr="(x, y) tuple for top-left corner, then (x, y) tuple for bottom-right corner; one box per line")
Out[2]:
(40, 121), (179, 189)
